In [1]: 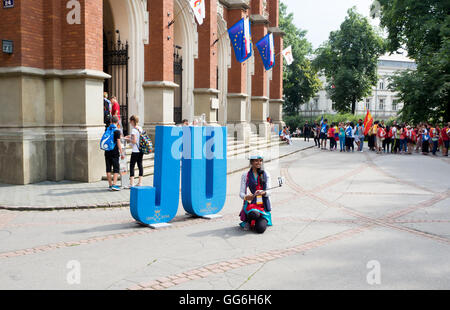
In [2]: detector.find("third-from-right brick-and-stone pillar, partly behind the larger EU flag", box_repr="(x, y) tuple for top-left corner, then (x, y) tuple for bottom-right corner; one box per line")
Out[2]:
(227, 1), (251, 144)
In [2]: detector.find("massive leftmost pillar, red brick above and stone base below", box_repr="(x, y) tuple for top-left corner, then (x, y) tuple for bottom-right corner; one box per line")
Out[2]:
(0, 0), (107, 184)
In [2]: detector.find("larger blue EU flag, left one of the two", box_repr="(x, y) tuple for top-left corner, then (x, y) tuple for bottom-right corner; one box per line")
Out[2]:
(228, 18), (253, 62)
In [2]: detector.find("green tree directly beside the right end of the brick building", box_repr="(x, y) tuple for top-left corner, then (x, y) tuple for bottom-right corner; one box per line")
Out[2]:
(279, 3), (321, 115)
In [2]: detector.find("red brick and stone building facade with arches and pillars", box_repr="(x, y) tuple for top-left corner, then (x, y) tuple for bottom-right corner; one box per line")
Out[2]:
(0, 0), (283, 184)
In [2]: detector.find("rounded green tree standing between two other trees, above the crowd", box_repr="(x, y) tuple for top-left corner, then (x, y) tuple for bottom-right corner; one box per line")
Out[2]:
(314, 8), (384, 114)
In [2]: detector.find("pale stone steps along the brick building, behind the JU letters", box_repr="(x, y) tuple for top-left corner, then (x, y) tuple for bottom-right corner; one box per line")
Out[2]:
(102, 134), (285, 180)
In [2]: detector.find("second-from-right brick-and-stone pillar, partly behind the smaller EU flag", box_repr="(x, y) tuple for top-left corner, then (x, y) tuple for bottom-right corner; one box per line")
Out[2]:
(251, 0), (270, 139)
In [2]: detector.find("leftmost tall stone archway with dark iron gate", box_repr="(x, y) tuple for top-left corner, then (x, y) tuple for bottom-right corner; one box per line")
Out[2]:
(103, 0), (148, 133)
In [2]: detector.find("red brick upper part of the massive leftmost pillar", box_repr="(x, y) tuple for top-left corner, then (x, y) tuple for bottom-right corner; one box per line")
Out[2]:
(0, 0), (103, 70)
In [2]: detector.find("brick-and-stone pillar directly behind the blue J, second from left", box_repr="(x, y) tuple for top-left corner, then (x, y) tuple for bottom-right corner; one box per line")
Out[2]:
(143, 0), (175, 137)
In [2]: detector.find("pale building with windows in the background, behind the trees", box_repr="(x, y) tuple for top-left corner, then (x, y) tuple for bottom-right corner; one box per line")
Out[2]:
(300, 55), (416, 120)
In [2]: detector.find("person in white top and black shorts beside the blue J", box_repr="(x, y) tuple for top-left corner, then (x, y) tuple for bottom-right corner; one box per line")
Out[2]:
(125, 115), (144, 188)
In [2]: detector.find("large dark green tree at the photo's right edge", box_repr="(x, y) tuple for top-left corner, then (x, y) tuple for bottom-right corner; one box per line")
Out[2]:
(377, 0), (450, 122)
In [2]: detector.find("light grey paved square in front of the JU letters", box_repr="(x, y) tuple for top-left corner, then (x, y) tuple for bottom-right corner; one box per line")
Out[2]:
(0, 143), (450, 290)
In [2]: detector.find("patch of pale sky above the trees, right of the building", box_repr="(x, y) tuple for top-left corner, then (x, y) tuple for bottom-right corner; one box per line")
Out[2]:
(281, 0), (378, 48)
